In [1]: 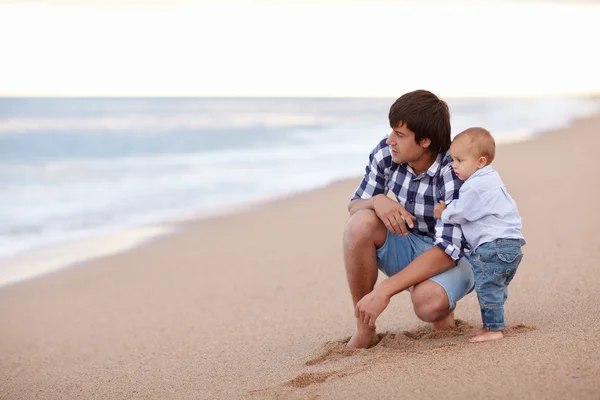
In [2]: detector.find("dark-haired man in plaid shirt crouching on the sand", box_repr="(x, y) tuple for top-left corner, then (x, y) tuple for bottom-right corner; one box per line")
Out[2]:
(344, 90), (474, 348)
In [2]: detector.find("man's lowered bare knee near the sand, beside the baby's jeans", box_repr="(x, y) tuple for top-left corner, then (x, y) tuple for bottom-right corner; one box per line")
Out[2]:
(410, 280), (451, 322)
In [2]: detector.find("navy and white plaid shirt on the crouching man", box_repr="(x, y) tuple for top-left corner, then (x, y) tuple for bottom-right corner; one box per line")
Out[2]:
(352, 139), (467, 260)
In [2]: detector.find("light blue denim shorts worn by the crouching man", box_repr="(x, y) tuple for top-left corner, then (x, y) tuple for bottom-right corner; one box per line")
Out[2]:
(377, 231), (475, 309)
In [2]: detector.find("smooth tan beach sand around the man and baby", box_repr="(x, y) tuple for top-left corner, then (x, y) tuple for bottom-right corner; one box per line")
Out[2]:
(0, 117), (600, 399)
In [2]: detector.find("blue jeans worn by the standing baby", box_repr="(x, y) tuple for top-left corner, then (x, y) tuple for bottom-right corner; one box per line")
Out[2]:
(468, 239), (523, 331)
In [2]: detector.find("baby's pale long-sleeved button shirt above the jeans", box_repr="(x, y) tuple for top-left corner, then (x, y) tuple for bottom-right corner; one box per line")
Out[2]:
(442, 165), (525, 251)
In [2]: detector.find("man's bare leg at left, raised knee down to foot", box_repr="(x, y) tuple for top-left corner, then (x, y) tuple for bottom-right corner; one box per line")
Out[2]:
(344, 210), (387, 348)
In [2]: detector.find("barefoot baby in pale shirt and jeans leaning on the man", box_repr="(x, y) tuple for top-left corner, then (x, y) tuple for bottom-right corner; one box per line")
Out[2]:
(434, 128), (525, 343)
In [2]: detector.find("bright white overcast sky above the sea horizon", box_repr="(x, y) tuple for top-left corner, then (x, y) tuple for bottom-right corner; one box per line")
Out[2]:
(0, 0), (600, 97)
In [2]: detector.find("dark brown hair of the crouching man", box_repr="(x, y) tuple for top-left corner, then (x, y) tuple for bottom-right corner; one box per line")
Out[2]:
(389, 90), (451, 154)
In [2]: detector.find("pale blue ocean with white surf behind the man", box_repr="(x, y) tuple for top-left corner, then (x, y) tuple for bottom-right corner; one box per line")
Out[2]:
(0, 97), (600, 283)
